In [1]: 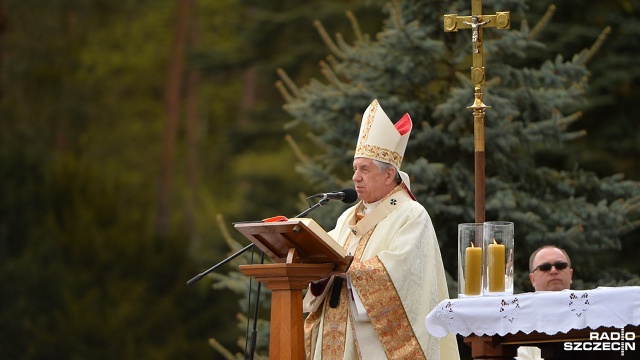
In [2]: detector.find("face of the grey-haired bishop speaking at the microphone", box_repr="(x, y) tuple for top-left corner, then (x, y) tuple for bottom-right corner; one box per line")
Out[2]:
(352, 158), (395, 204)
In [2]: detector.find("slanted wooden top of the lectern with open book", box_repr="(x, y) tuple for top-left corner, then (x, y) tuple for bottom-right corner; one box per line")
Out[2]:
(234, 218), (353, 271)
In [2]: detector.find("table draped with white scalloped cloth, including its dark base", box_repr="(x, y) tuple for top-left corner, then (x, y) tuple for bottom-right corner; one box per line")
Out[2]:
(425, 286), (640, 359)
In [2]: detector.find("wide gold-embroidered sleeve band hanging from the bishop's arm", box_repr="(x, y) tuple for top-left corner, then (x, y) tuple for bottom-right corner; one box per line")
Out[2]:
(349, 257), (425, 359)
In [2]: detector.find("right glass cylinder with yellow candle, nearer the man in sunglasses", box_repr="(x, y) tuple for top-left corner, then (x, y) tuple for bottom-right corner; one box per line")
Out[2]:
(482, 221), (514, 295)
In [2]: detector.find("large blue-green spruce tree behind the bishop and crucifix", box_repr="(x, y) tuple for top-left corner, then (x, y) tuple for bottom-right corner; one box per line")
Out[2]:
(280, 0), (640, 296)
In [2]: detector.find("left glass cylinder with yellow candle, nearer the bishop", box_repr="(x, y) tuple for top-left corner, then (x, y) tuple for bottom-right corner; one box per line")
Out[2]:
(458, 223), (483, 298)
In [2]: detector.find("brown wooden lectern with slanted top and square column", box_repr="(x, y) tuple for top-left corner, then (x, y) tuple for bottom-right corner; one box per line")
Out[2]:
(234, 218), (353, 360)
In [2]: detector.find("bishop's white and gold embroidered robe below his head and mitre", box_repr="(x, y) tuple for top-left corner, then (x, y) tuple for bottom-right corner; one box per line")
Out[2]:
(305, 187), (459, 360)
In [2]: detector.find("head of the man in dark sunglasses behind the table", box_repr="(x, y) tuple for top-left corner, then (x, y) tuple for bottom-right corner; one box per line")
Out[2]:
(529, 245), (573, 291)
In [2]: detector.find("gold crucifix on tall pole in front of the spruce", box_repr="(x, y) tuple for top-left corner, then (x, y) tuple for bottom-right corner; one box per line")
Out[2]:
(444, 0), (511, 223)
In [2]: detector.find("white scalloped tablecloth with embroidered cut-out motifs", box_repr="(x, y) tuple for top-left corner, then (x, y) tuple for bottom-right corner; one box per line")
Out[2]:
(425, 286), (640, 337)
